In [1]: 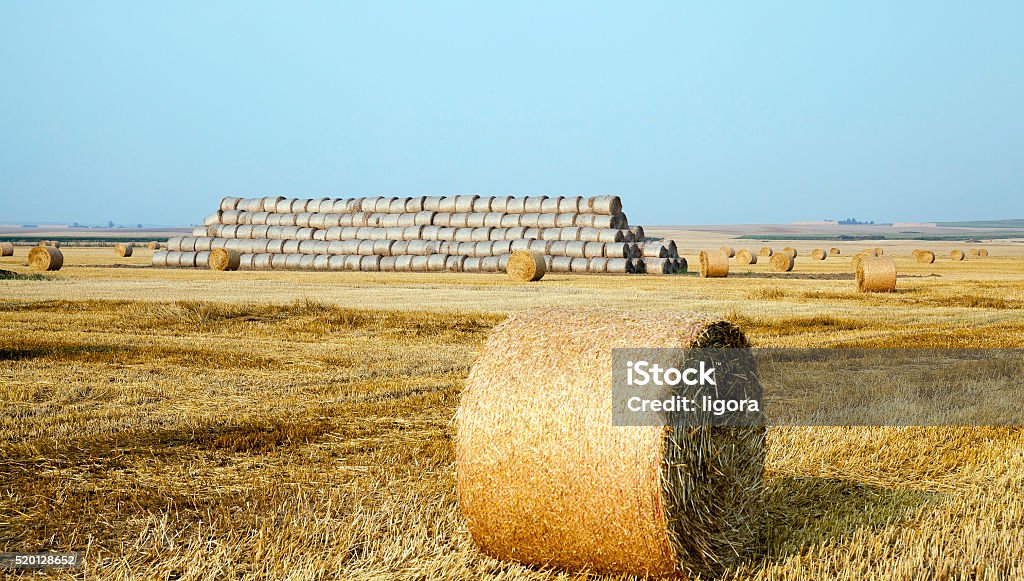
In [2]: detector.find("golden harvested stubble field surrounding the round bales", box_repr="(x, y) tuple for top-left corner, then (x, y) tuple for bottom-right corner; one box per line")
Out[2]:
(0, 239), (1024, 580)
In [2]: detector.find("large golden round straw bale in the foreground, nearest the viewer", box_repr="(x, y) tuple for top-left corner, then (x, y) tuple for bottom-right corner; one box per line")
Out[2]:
(455, 309), (765, 576)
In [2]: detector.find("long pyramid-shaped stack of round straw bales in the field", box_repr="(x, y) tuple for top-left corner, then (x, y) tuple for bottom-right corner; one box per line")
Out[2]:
(153, 196), (685, 274)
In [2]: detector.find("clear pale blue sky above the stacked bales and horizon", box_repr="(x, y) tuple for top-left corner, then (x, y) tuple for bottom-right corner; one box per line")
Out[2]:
(0, 0), (1024, 224)
